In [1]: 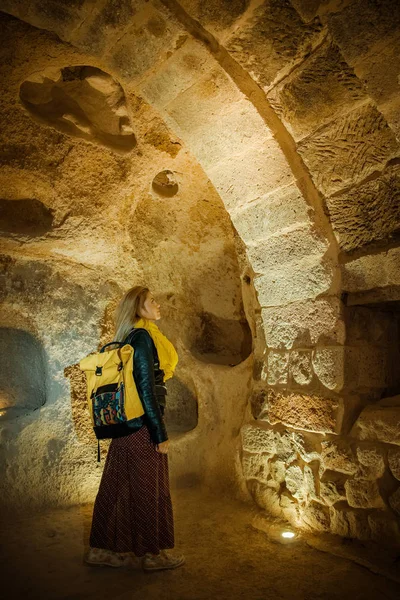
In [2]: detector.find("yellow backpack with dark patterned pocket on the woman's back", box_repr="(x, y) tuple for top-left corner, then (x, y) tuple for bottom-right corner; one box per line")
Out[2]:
(79, 342), (144, 461)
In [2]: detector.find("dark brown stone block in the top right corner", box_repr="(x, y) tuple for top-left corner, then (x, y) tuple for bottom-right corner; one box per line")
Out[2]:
(328, 0), (400, 64)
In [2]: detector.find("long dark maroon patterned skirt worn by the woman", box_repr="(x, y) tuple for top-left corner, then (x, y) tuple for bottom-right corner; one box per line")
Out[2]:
(90, 426), (174, 556)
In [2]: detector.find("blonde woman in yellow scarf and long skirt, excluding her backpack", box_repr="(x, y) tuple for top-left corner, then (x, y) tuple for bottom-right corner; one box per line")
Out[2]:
(86, 286), (185, 571)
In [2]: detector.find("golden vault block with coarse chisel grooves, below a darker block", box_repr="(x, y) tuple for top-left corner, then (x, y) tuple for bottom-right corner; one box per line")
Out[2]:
(298, 104), (400, 197)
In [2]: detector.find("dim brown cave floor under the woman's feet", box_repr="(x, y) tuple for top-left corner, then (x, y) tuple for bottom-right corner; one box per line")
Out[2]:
(1, 488), (400, 600)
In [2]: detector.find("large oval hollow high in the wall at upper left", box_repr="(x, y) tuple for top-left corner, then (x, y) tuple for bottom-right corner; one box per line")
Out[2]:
(20, 66), (136, 152)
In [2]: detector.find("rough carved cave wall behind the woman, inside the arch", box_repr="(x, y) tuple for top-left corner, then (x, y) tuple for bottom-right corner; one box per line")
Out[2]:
(0, 14), (254, 510)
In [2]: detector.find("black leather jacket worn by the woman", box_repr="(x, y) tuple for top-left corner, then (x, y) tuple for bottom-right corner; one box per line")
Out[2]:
(125, 328), (168, 444)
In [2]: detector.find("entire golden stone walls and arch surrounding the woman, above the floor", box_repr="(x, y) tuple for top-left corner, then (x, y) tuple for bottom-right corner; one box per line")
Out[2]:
(0, 0), (400, 545)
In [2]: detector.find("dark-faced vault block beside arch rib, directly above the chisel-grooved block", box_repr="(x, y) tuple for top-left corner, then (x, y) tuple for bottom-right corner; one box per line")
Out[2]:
(268, 41), (367, 141)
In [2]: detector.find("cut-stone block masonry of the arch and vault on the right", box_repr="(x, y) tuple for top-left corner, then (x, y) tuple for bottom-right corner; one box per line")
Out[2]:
(2, 0), (400, 543)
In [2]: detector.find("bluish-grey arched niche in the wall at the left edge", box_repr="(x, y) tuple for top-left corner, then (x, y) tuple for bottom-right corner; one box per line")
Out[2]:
(0, 327), (47, 421)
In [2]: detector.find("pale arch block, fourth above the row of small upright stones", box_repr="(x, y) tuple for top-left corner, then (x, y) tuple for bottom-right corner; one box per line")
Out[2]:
(231, 183), (312, 244)
